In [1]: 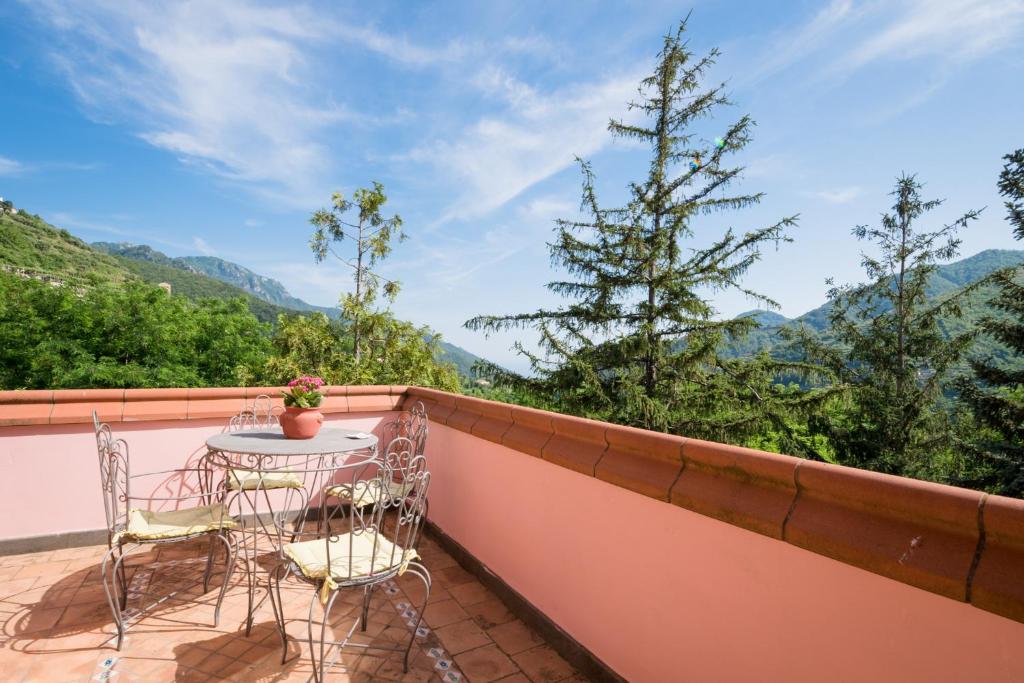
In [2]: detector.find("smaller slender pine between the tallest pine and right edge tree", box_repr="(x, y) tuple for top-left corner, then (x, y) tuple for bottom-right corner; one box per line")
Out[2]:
(801, 175), (979, 478)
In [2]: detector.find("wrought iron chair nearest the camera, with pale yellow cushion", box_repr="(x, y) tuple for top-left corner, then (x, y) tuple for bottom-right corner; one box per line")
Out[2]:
(270, 436), (431, 681)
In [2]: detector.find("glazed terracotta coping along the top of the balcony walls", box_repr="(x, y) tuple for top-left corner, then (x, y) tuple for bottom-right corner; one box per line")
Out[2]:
(0, 386), (1024, 622)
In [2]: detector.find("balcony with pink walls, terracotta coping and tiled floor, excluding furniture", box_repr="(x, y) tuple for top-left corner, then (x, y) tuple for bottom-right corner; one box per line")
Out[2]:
(0, 386), (1024, 681)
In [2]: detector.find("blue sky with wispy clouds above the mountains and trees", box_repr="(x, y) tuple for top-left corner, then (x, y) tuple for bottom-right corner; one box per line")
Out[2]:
(0, 0), (1024, 368)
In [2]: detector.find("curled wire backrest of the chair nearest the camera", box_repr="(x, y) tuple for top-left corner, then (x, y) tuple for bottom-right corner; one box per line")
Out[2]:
(326, 436), (430, 579)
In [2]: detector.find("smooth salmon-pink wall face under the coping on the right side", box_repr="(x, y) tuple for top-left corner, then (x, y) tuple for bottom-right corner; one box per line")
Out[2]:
(427, 424), (1024, 682)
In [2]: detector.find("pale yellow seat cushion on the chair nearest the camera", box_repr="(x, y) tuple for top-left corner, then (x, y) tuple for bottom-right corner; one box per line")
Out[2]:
(283, 528), (419, 602)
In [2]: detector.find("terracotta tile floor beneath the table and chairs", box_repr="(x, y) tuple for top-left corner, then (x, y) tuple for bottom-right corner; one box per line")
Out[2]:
(0, 538), (585, 683)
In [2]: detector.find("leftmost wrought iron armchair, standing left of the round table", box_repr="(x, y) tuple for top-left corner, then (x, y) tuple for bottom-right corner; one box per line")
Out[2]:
(92, 411), (238, 650)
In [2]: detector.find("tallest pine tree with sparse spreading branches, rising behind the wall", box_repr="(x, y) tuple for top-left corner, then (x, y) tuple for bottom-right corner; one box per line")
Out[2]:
(466, 20), (823, 447)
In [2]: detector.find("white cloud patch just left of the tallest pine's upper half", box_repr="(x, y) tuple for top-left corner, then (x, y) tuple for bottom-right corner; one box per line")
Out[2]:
(410, 68), (641, 221)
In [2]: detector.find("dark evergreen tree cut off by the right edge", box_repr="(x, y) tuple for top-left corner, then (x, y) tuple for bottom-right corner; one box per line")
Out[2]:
(959, 148), (1024, 496)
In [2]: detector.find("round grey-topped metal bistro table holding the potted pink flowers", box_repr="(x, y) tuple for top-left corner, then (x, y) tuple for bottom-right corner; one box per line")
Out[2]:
(206, 428), (377, 635)
